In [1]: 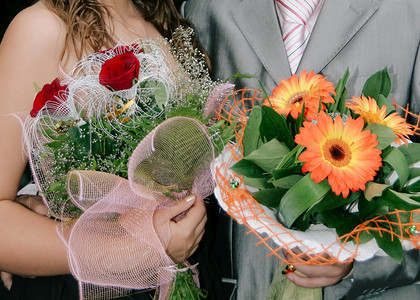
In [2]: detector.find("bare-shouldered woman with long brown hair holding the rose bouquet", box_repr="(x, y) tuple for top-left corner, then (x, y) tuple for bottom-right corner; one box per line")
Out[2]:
(0, 0), (206, 299)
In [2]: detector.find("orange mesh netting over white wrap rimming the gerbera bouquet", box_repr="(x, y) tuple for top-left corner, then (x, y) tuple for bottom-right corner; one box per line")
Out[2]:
(213, 89), (420, 265)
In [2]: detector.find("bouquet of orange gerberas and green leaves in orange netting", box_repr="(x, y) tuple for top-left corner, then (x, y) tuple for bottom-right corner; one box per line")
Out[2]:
(212, 69), (420, 265)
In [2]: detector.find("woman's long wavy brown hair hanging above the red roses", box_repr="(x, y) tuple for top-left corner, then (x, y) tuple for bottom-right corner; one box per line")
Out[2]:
(42, 0), (203, 63)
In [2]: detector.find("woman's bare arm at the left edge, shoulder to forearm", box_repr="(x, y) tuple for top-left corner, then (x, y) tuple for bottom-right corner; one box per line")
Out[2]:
(0, 3), (69, 276)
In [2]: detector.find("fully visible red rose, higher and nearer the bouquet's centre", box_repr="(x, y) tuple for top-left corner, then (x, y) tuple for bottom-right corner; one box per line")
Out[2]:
(99, 52), (140, 91)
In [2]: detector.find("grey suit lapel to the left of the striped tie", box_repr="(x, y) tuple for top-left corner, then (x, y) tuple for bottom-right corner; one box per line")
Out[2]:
(232, 0), (291, 83)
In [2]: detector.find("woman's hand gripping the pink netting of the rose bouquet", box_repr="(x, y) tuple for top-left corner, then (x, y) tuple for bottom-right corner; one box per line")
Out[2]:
(155, 195), (207, 263)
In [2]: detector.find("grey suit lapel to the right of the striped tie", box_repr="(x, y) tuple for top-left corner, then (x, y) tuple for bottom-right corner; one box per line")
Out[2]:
(297, 0), (379, 74)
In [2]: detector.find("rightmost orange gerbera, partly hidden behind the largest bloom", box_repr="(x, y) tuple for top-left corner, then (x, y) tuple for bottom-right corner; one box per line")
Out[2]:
(346, 96), (413, 145)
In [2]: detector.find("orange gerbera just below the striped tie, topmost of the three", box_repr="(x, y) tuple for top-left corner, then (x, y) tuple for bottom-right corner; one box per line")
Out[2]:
(263, 70), (335, 120)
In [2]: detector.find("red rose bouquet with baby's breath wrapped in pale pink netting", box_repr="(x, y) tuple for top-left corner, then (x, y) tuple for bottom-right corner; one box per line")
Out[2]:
(18, 28), (233, 299)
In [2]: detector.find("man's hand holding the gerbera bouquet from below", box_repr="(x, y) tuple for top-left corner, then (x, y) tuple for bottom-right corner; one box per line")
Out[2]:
(283, 249), (353, 288)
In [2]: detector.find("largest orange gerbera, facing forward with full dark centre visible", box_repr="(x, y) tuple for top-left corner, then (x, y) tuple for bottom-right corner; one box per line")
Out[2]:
(295, 112), (382, 198)
